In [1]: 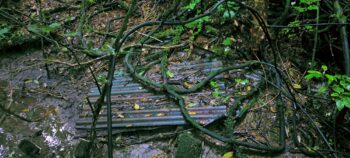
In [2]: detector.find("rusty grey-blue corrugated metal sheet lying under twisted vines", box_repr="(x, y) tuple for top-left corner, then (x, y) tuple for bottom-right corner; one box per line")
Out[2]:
(76, 61), (226, 135)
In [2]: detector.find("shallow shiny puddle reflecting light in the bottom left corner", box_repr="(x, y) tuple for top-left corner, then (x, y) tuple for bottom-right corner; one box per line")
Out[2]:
(0, 80), (73, 158)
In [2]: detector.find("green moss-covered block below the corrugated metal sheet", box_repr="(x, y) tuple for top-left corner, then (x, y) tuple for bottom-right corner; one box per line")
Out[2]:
(175, 133), (202, 158)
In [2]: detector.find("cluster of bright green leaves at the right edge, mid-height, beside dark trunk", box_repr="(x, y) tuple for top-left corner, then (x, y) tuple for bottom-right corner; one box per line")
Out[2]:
(304, 65), (350, 110)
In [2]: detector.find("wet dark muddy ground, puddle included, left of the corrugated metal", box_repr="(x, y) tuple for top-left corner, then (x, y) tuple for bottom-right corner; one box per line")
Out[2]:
(0, 50), (90, 157)
